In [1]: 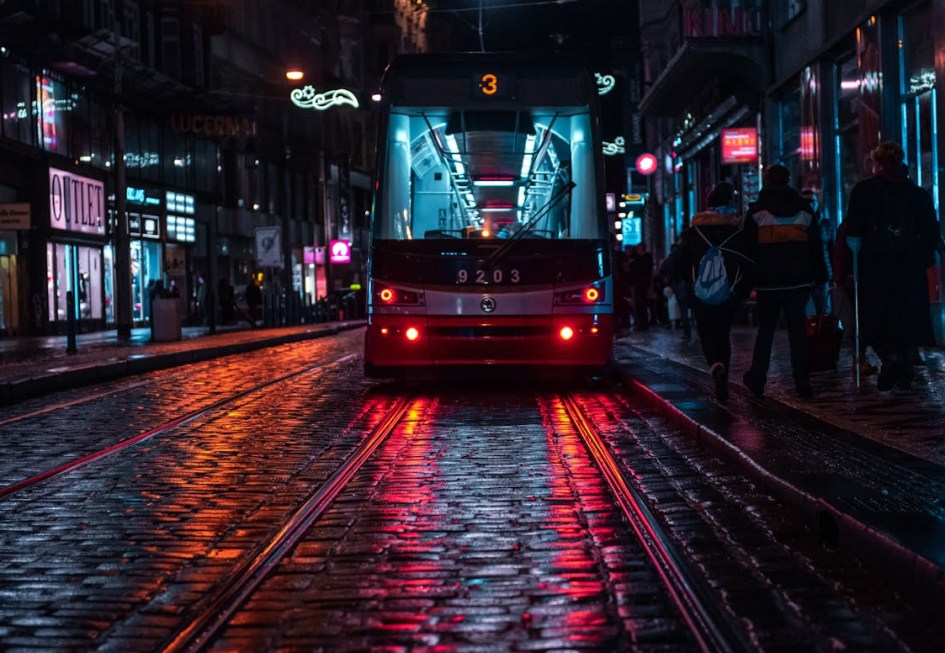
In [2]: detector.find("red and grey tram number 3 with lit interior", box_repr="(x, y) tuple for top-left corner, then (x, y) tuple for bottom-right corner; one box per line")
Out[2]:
(364, 53), (614, 377)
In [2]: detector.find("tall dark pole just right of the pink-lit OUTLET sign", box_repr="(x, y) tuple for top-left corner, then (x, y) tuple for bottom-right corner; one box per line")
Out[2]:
(112, 0), (132, 340)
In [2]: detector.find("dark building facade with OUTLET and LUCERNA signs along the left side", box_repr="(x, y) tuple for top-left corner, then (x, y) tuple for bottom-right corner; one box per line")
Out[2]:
(0, 0), (412, 336)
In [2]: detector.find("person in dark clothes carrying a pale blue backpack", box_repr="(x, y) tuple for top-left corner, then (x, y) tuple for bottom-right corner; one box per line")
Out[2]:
(673, 181), (752, 401)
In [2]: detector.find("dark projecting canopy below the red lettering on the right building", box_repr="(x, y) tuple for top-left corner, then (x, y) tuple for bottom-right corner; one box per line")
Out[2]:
(640, 40), (766, 116)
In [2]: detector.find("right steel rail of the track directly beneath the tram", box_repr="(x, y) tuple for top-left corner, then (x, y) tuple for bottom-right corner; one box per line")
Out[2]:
(561, 395), (753, 653)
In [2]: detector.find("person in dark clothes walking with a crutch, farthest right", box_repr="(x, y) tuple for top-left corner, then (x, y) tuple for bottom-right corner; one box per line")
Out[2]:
(845, 141), (941, 391)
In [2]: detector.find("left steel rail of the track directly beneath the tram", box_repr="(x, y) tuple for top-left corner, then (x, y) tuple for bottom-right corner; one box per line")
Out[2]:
(161, 397), (413, 653)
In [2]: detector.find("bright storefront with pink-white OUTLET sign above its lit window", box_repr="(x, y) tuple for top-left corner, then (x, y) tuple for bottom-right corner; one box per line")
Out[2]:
(46, 168), (106, 333)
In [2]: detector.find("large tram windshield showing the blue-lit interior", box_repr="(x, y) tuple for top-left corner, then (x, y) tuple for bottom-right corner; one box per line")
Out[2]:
(374, 106), (606, 241)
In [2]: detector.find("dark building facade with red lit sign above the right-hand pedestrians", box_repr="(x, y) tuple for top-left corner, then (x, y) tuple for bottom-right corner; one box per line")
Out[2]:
(641, 0), (945, 342)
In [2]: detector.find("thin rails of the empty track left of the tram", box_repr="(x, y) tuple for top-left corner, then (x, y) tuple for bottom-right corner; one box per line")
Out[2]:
(0, 354), (357, 499)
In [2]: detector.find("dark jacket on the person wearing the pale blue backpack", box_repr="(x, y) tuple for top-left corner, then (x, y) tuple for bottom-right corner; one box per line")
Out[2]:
(673, 208), (753, 303)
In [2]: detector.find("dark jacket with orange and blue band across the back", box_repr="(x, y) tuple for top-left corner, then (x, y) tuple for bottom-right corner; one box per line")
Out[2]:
(745, 181), (827, 290)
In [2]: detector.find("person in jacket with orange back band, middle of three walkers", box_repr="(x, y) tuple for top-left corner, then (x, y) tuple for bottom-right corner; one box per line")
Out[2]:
(742, 164), (827, 399)
